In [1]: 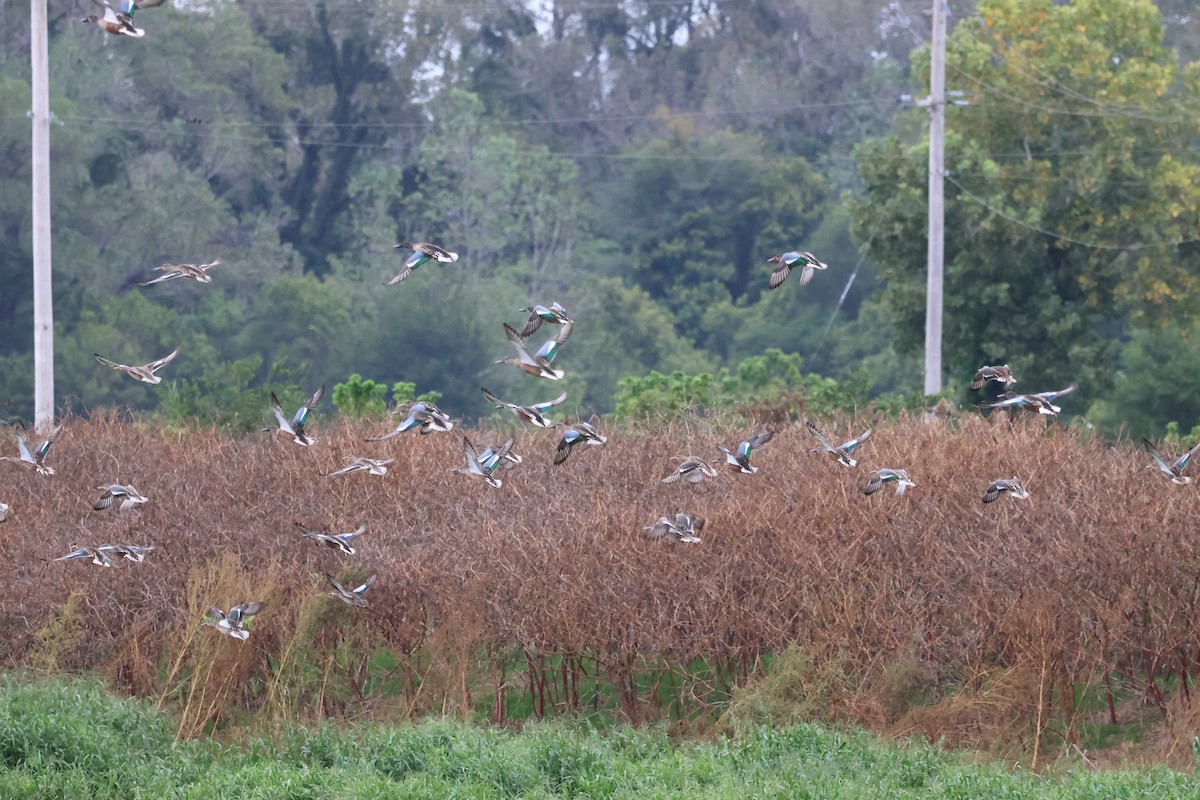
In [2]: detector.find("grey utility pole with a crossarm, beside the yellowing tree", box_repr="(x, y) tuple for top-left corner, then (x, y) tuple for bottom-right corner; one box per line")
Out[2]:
(925, 0), (946, 395)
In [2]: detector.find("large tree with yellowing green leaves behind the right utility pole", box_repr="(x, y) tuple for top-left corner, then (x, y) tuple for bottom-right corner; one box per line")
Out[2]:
(852, 0), (1200, 410)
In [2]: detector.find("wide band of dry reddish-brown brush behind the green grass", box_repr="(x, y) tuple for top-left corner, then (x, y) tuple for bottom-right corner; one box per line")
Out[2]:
(0, 414), (1200, 758)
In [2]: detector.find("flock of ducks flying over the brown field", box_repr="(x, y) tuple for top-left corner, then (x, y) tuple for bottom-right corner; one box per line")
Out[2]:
(14, 0), (1200, 640)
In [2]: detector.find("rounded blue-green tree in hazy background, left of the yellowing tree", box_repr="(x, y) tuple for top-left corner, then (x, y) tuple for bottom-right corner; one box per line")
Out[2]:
(611, 124), (828, 347)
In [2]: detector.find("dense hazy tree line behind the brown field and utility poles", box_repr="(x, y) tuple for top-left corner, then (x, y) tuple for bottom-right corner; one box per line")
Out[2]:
(0, 0), (1200, 432)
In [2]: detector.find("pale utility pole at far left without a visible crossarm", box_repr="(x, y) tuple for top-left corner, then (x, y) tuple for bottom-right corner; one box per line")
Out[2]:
(29, 0), (54, 429)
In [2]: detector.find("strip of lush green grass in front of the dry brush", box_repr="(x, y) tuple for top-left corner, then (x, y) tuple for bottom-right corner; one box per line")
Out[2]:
(0, 676), (1200, 800)
